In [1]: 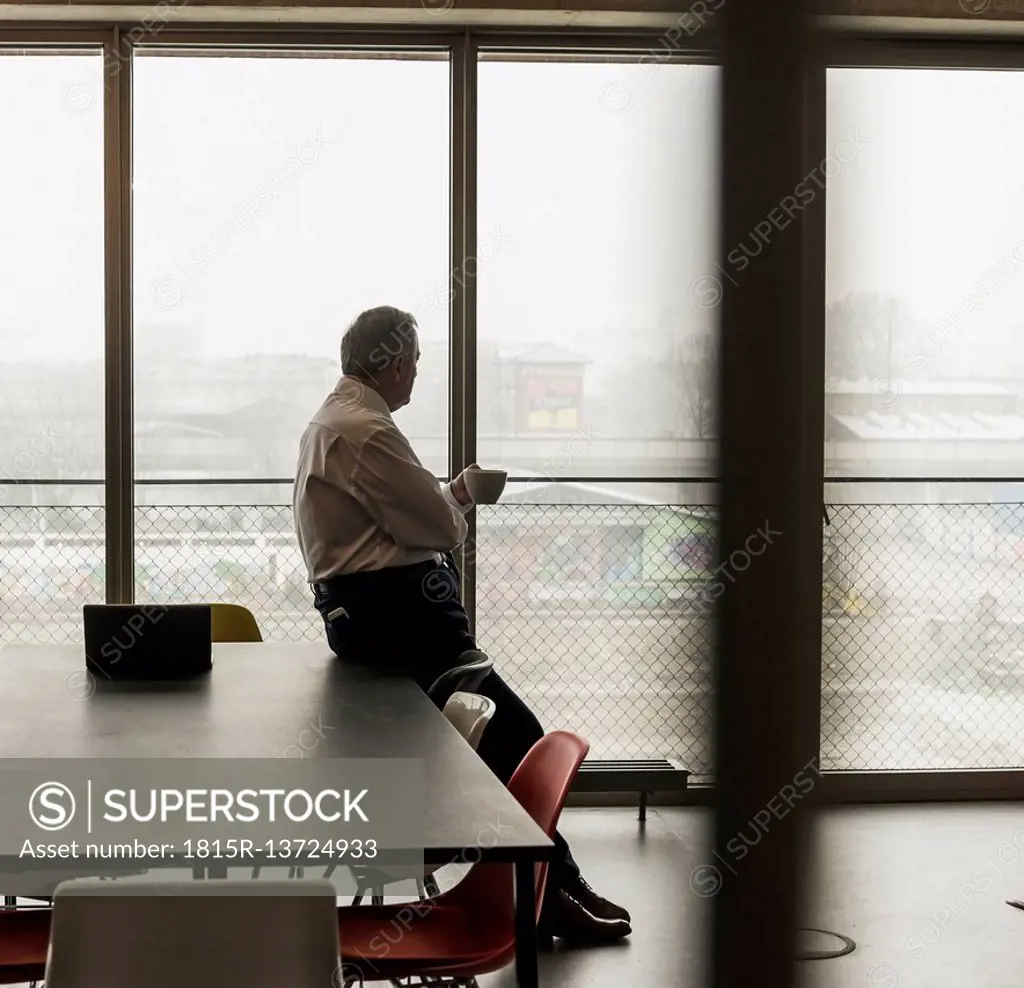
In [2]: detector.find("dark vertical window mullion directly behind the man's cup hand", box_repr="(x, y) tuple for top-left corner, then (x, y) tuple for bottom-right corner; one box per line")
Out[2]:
(449, 32), (476, 631)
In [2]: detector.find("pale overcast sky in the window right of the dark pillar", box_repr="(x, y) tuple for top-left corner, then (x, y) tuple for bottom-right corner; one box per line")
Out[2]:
(827, 63), (1024, 376)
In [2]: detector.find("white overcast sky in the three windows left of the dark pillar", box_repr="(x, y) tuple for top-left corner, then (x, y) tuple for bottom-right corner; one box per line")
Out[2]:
(0, 51), (716, 366)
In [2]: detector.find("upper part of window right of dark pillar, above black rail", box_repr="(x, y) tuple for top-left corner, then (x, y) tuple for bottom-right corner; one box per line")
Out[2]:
(826, 69), (1024, 479)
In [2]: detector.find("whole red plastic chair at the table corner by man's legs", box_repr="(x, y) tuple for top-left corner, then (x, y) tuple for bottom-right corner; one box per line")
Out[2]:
(338, 731), (590, 988)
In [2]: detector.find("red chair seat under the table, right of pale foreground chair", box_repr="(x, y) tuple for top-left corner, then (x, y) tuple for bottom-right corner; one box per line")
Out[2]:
(338, 896), (514, 981)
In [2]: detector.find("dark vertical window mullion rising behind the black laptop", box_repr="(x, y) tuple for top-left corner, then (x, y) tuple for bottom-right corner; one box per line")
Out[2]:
(102, 28), (134, 603)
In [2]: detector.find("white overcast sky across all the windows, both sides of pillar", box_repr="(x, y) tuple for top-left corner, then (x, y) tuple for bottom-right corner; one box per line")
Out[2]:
(6, 56), (1024, 373)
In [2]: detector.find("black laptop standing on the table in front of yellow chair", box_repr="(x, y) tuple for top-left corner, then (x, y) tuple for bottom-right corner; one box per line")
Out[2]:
(82, 604), (213, 680)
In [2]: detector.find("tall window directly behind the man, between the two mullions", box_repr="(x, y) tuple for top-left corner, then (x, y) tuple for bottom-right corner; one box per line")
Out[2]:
(133, 51), (451, 635)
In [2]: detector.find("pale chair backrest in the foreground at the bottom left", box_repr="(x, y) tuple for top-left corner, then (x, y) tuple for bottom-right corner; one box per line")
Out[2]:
(45, 879), (339, 988)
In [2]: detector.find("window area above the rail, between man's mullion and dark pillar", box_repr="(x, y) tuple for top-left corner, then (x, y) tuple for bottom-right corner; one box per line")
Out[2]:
(477, 60), (718, 479)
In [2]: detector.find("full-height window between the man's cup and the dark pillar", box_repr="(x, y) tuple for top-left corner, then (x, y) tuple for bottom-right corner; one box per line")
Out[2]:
(476, 56), (720, 775)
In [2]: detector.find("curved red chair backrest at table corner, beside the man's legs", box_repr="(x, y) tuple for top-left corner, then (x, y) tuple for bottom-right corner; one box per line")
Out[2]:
(444, 731), (590, 929)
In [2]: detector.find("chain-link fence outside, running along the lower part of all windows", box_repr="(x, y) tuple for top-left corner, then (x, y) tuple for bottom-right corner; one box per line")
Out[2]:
(0, 504), (1024, 777)
